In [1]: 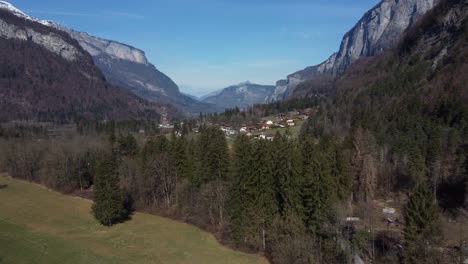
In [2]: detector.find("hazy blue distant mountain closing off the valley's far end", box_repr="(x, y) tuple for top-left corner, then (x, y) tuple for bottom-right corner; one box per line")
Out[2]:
(201, 81), (275, 109)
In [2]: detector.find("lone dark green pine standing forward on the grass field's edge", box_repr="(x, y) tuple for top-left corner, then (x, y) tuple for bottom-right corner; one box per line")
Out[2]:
(91, 154), (128, 226)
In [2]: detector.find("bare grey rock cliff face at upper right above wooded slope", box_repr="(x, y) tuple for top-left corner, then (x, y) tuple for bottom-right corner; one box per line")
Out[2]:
(266, 0), (438, 102)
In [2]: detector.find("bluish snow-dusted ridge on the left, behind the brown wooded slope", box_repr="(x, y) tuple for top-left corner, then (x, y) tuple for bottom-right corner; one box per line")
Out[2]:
(0, 1), (219, 114)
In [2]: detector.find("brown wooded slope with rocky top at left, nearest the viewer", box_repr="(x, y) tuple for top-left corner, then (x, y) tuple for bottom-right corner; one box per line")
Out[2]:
(0, 10), (173, 122)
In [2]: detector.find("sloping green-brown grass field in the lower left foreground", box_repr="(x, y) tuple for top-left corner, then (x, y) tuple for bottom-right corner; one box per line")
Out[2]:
(0, 176), (267, 264)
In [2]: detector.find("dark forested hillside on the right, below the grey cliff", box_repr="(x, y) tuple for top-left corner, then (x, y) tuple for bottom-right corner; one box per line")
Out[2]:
(303, 0), (468, 206)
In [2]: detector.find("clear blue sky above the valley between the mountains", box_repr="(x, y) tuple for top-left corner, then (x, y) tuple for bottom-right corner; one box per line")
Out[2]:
(10, 0), (378, 95)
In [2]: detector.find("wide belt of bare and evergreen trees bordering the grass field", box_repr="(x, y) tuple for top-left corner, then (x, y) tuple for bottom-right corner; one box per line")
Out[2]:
(0, 127), (358, 263)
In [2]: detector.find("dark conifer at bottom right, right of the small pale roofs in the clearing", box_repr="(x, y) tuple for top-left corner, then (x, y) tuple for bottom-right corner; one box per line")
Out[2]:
(403, 183), (439, 263)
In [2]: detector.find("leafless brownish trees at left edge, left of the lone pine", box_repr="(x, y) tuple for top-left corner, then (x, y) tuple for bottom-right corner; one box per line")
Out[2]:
(0, 137), (103, 193)
